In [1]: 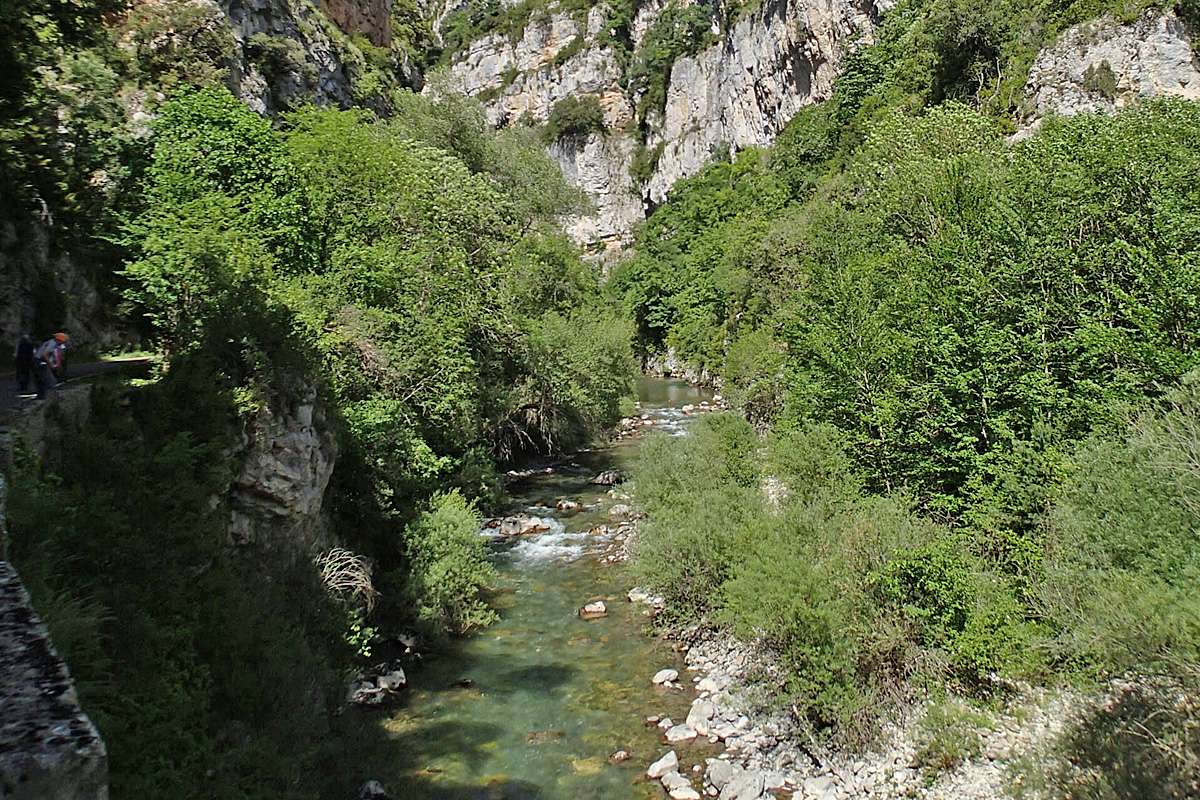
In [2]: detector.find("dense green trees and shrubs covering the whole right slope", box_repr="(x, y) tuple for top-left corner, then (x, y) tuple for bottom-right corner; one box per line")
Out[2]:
(612, 2), (1200, 796)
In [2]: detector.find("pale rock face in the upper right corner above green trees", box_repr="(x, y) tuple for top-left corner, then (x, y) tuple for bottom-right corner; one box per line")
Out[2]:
(1021, 11), (1200, 134)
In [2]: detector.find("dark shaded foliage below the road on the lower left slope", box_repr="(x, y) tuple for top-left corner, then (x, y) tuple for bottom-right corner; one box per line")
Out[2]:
(8, 376), (344, 799)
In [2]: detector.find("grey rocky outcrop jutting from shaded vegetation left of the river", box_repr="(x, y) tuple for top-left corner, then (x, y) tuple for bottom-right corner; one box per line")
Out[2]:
(229, 385), (337, 554)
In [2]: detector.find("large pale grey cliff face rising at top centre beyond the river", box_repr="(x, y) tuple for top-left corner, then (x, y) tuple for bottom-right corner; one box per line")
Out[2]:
(449, 0), (880, 259)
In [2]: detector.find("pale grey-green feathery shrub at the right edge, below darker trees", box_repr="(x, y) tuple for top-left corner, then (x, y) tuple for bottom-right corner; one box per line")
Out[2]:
(1038, 373), (1200, 675)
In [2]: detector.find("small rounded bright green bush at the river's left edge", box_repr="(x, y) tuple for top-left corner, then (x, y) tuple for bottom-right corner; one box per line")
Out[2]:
(404, 492), (496, 633)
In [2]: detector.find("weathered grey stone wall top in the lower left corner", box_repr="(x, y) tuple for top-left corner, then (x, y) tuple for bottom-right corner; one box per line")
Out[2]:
(0, 561), (108, 800)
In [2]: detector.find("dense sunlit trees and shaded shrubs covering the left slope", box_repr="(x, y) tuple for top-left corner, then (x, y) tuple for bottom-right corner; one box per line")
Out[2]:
(0, 2), (632, 798)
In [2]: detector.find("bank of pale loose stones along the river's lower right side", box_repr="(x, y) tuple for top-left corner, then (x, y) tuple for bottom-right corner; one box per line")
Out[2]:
(631, 618), (1084, 800)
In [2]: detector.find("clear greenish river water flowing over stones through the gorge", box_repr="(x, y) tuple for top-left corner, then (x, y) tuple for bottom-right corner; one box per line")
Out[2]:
(360, 379), (713, 800)
